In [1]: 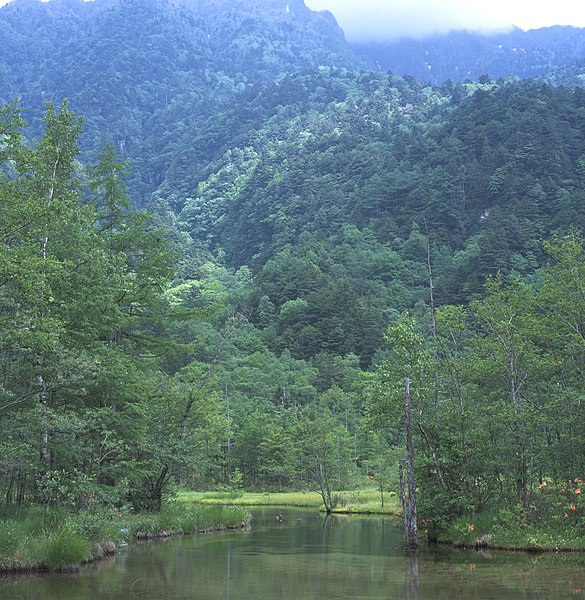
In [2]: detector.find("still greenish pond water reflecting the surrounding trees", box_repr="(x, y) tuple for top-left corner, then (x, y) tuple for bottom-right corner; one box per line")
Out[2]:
(0, 509), (585, 600)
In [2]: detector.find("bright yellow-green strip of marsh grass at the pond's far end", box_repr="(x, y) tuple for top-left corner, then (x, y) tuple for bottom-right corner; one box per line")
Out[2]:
(177, 488), (399, 515)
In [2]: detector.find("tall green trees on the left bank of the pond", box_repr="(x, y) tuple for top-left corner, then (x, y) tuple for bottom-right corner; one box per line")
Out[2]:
(0, 104), (179, 508)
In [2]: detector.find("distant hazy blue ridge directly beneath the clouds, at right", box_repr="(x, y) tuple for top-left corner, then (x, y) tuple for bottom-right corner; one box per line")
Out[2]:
(353, 26), (585, 85)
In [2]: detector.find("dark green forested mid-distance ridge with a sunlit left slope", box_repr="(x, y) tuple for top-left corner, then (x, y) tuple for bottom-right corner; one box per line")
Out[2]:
(176, 74), (585, 301)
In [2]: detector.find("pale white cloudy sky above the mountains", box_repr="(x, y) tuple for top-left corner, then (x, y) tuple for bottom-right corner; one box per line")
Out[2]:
(0, 0), (585, 41)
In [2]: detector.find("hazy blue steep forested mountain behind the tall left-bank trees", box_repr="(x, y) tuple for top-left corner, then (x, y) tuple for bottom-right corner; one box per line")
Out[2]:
(0, 0), (364, 202)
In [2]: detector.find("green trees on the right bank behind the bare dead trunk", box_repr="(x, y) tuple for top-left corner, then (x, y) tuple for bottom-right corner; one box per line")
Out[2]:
(366, 231), (584, 543)
